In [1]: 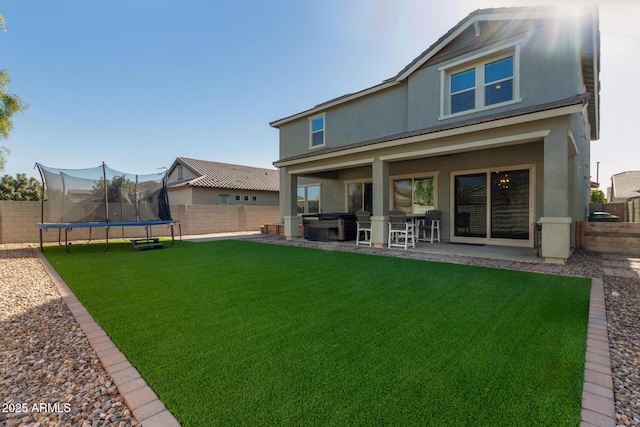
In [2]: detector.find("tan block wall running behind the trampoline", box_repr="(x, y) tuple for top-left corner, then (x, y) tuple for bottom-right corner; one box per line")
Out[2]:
(0, 200), (281, 244)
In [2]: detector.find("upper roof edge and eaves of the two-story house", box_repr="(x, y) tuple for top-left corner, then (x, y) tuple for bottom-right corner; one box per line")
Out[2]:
(270, 6), (600, 139)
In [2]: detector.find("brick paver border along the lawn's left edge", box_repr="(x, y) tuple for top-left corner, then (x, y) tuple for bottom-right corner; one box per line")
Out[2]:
(37, 251), (180, 427)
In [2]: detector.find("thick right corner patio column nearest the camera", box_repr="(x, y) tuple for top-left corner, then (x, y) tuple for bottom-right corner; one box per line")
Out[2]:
(540, 125), (572, 264)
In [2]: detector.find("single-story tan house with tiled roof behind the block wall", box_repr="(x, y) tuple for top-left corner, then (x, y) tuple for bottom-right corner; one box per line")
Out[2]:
(167, 157), (280, 206)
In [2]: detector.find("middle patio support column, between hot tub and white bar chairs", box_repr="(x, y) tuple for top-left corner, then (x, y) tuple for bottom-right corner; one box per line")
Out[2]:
(371, 158), (389, 247)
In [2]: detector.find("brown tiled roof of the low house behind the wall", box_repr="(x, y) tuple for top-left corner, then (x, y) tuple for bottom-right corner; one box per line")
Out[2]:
(169, 157), (280, 191)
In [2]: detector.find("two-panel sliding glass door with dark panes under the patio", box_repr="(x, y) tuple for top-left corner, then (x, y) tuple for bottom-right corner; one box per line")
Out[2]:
(453, 168), (531, 244)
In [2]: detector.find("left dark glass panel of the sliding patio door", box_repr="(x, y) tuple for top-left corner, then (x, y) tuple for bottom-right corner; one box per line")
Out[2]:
(454, 173), (487, 238)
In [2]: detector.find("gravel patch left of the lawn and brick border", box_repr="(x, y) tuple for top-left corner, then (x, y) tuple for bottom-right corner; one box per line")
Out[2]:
(0, 245), (139, 426)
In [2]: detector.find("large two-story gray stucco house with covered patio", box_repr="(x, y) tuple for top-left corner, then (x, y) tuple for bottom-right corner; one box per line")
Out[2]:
(271, 7), (600, 263)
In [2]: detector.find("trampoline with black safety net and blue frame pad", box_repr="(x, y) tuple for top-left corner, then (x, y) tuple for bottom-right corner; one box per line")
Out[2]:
(36, 163), (182, 252)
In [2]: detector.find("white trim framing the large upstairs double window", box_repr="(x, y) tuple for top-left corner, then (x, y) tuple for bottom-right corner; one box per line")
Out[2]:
(438, 40), (522, 120)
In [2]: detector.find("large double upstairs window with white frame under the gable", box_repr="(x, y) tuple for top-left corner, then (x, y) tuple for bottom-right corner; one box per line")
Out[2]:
(440, 46), (520, 118)
